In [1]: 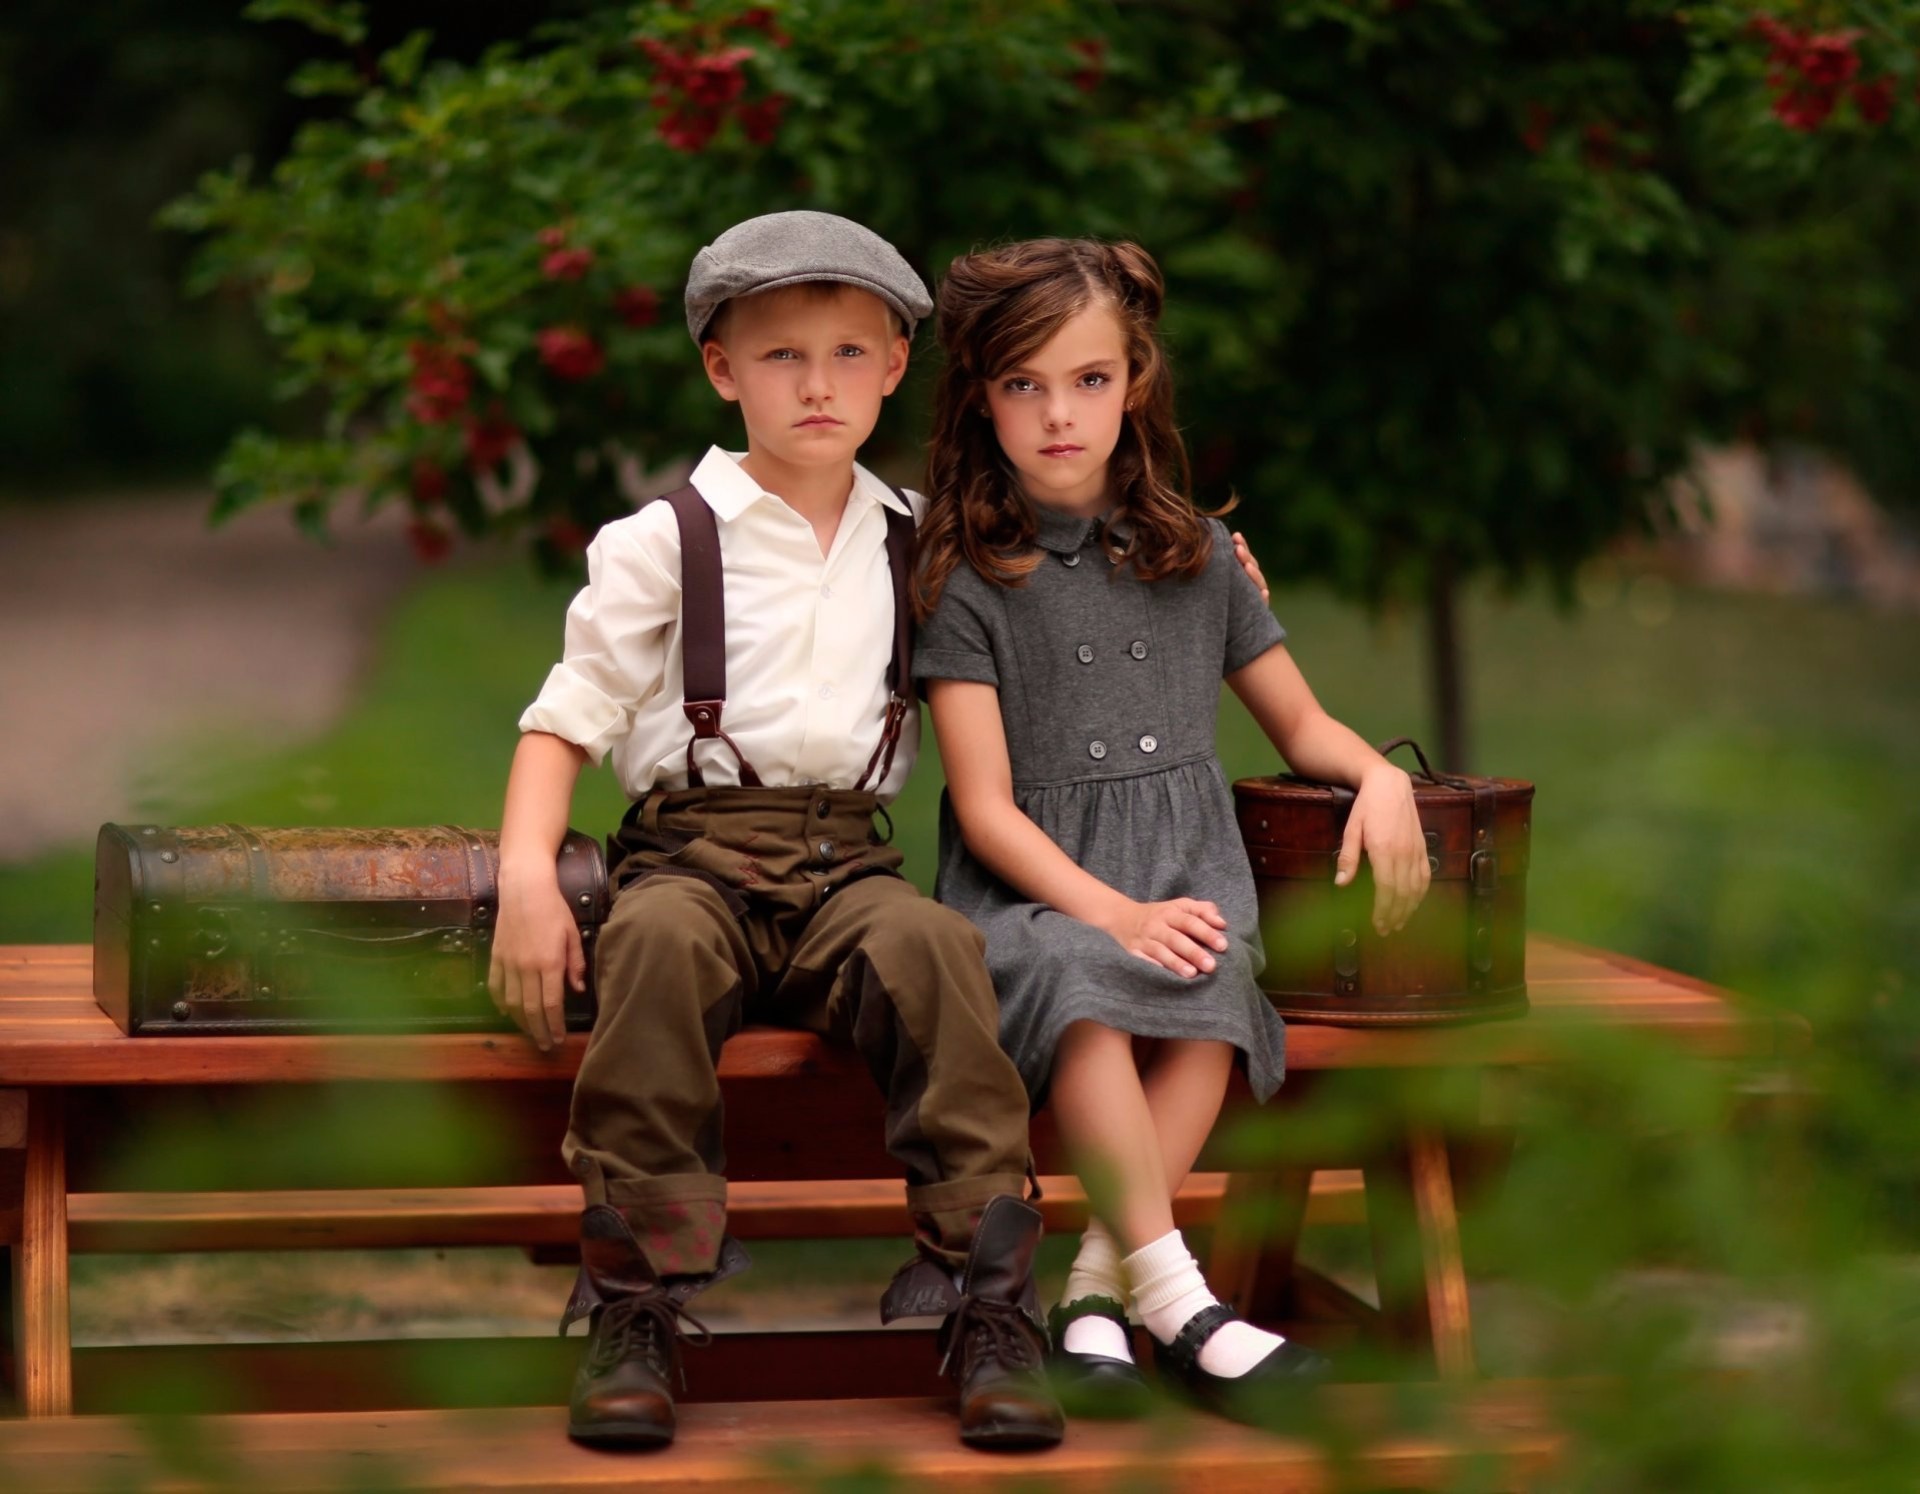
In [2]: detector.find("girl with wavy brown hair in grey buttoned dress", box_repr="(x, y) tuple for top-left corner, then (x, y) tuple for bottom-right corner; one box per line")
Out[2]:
(914, 238), (1427, 1410)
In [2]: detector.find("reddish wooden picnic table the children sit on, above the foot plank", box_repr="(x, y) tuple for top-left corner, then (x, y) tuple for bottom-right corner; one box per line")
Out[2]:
(0, 937), (1805, 1488)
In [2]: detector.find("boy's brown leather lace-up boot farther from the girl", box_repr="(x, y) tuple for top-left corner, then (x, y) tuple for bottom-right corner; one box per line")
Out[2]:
(561, 1204), (745, 1448)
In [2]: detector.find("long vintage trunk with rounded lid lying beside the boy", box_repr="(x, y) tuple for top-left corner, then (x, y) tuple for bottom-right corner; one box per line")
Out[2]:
(94, 824), (609, 1037)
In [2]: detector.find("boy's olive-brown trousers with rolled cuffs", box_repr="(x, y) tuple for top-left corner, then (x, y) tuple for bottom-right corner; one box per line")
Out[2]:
(564, 787), (1029, 1275)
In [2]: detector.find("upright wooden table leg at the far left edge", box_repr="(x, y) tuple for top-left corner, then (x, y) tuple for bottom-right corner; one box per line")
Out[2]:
(13, 1089), (73, 1417)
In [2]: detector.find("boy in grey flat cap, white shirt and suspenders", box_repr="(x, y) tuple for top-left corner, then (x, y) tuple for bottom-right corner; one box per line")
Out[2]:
(490, 213), (1062, 1446)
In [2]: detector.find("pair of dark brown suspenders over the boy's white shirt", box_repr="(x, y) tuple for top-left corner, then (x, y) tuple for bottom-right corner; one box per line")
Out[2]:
(660, 484), (914, 789)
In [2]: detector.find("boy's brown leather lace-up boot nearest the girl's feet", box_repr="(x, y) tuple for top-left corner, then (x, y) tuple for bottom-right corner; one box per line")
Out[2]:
(941, 1194), (1066, 1448)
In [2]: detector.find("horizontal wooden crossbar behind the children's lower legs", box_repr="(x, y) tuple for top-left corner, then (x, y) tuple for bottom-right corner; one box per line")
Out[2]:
(67, 1171), (1365, 1252)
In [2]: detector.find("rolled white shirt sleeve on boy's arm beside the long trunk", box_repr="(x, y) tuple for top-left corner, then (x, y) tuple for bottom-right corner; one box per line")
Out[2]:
(520, 503), (680, 764)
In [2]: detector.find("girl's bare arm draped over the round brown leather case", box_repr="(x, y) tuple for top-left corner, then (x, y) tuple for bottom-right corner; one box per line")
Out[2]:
(1227, 645), (1428, 933)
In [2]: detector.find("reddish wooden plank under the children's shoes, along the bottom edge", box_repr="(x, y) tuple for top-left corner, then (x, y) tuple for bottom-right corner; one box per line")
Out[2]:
(0, 1385), (1567, 1494)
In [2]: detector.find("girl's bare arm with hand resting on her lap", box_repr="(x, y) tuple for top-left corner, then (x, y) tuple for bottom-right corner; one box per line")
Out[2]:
(927, 680), (1228, 976)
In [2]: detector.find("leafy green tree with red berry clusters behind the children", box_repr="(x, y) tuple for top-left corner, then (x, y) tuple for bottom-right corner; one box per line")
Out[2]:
(171, 0), (1920, 766)
